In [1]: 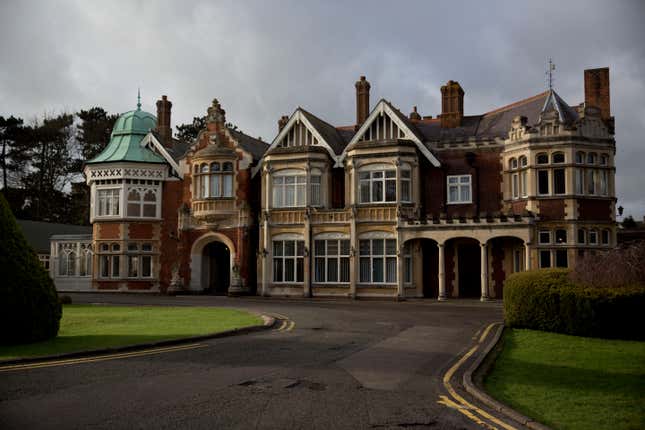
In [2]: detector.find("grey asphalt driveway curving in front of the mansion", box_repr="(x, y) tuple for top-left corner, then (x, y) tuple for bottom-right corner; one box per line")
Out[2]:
(0, 294), (502, 429)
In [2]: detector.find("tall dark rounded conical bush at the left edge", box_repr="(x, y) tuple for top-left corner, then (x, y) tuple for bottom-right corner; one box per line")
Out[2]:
(0, 194), (62, 345)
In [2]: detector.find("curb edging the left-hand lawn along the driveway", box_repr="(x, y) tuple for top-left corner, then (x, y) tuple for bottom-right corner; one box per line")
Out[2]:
(0, 314), (275, 366)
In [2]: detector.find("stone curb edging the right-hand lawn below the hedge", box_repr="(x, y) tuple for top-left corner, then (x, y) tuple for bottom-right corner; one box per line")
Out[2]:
(462, 323), (551, 430)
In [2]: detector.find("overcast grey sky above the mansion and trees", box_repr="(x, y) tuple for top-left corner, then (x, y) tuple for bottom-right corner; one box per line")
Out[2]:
(0, 0), (645, 218)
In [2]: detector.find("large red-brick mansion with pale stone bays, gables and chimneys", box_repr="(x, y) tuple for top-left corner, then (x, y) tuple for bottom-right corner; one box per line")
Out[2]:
(52, 68), (616, 300)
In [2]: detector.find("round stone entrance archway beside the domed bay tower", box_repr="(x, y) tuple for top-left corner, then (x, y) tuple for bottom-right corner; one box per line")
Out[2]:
(189, 232), (237, 292)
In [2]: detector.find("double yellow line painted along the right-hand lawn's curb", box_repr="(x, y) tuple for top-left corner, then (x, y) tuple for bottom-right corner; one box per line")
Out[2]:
(437, 323), (517, 430)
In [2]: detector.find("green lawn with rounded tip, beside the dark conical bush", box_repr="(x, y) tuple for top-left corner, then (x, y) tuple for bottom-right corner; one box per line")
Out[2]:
(0, 305), (262, 360)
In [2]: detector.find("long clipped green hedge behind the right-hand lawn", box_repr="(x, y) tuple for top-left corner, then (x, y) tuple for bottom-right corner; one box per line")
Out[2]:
(504, 269), (645, 340)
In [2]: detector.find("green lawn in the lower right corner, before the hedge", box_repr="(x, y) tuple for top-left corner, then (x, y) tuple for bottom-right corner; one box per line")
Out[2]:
(484, 329), (645, 430)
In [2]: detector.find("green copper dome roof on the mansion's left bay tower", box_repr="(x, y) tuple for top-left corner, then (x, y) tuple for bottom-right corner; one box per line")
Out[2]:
(87, 103), (166, 164)
